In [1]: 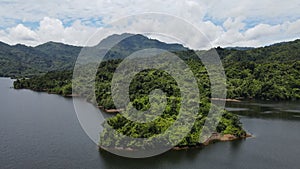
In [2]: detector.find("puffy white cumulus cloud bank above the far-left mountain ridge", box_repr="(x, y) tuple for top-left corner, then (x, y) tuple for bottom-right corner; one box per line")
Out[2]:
(0, 17), (98, 46)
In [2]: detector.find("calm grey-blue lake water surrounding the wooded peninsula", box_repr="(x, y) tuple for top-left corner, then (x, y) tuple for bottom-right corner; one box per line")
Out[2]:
(0, 78), (300, 169)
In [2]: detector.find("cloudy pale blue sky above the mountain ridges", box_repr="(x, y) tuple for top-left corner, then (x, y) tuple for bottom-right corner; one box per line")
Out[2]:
(0, 0), (300, 49)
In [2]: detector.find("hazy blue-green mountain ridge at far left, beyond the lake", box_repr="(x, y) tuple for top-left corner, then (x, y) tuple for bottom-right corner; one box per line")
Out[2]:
(0, 42), (81, 78)
